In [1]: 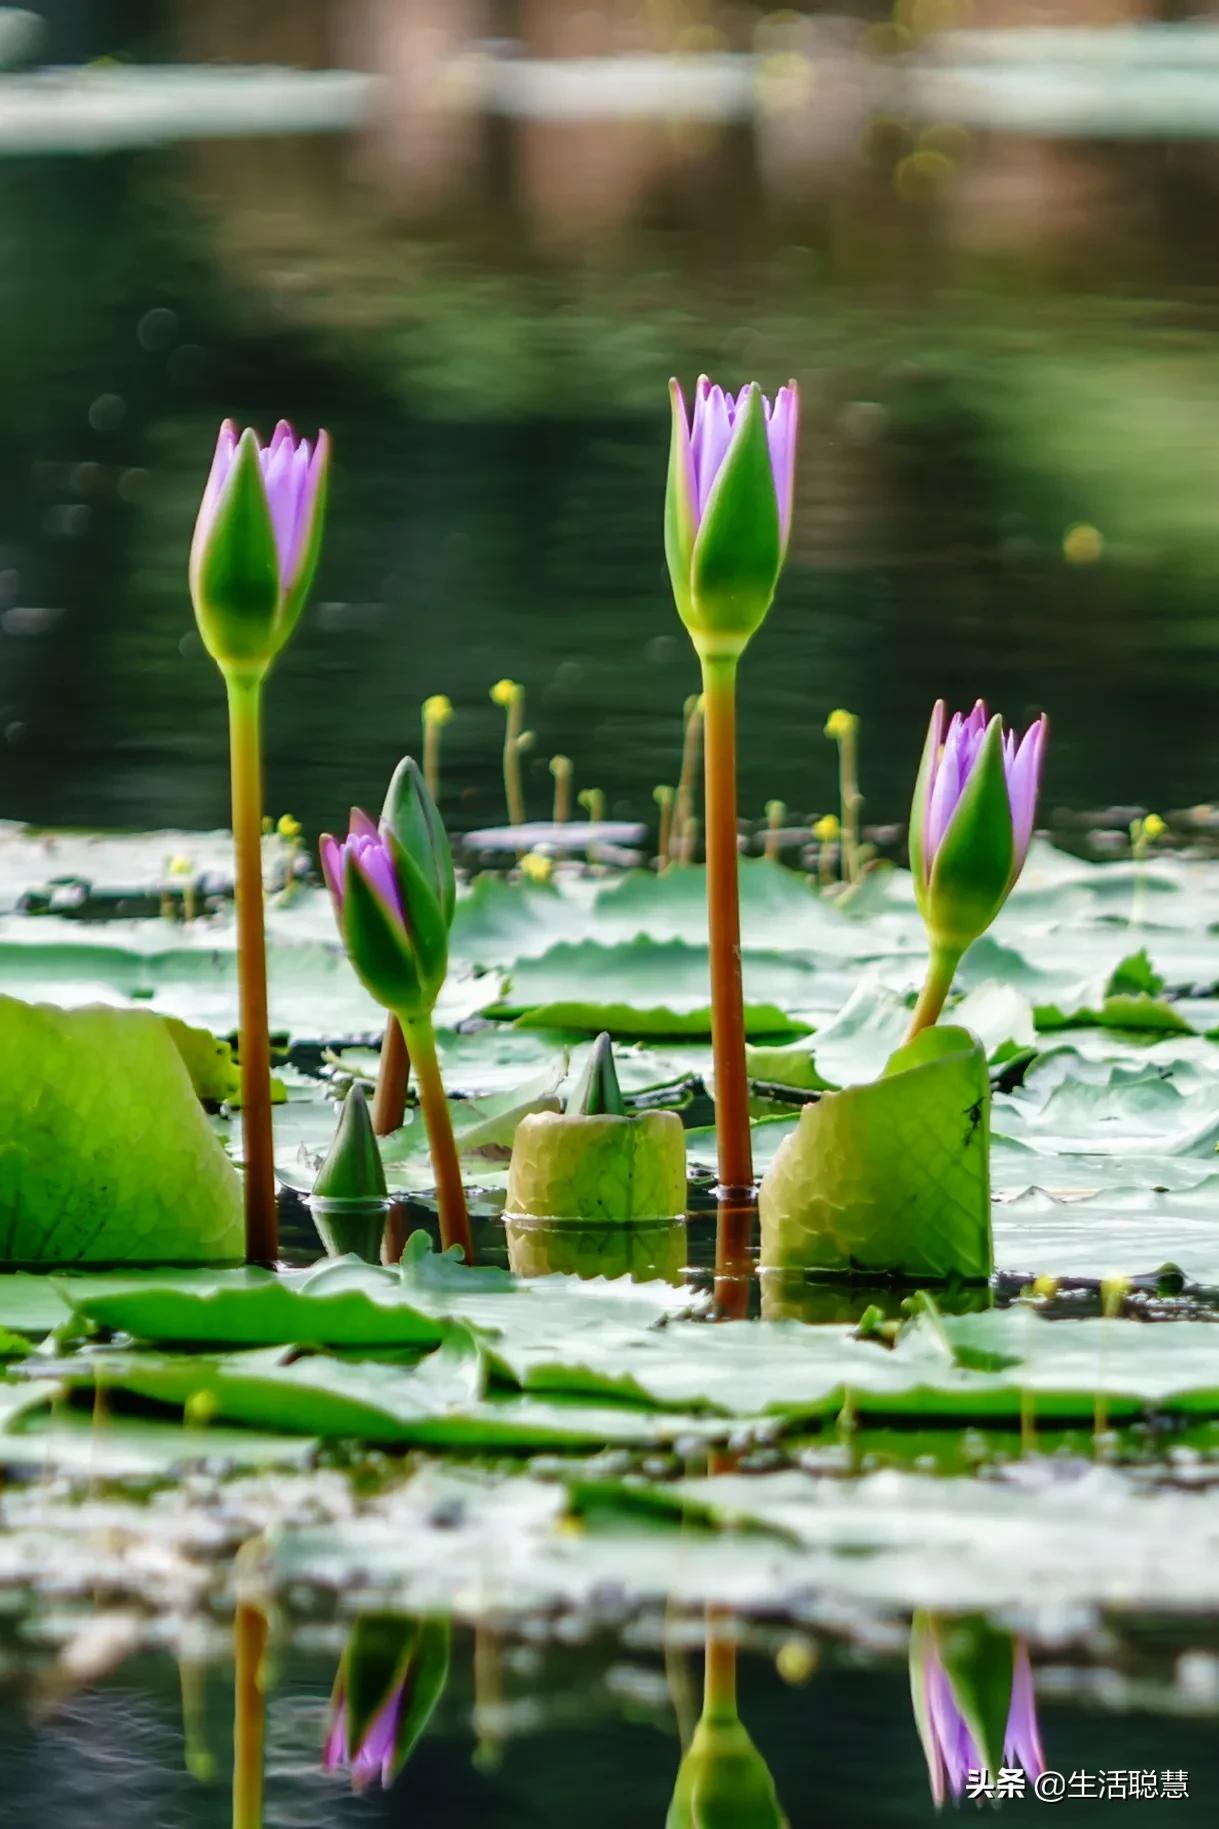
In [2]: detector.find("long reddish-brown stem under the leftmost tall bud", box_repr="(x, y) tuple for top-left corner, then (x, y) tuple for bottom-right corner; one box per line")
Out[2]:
(225, 675), (278, 1264)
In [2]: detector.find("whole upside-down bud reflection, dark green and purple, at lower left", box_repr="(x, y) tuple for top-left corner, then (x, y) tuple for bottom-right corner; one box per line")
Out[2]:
(322, 1613), (452, 1791)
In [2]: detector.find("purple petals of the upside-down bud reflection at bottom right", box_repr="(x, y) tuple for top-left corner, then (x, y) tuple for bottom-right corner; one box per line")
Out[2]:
(912, 1624), (1045, 1807)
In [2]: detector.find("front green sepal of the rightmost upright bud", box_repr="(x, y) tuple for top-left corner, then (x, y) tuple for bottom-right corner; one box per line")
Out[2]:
(912, 717), (1016, 953)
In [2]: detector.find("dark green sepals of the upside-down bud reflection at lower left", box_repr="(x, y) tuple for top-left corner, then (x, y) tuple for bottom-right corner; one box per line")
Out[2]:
(331, 1613), (452, 1780)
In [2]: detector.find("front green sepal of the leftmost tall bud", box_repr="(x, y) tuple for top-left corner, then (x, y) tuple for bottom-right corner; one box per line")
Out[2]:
(190, 430), (280, 669)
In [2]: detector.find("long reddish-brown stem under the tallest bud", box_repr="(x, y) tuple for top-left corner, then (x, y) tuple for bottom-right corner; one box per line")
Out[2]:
(703, 657), (754, 1193)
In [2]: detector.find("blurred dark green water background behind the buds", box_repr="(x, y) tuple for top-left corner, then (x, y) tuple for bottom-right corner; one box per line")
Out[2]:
(0, 0), (1219, 834)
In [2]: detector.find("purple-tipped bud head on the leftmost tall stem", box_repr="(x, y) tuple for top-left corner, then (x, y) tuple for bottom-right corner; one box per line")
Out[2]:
(190, 419), (329, 673)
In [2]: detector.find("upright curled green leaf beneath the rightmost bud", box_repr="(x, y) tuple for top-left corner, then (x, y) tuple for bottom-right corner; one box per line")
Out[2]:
(758, 1028), (994, 1282)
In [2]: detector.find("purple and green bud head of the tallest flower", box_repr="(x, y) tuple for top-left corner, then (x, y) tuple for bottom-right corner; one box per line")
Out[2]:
(664, 375), (800, 658)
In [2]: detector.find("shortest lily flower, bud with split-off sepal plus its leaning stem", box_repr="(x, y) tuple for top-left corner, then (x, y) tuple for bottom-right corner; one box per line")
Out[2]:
(322, 757), (474, 1264)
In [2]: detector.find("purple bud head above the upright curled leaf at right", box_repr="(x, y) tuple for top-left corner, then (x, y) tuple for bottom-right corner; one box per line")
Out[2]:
(910, 699), (1049, 957)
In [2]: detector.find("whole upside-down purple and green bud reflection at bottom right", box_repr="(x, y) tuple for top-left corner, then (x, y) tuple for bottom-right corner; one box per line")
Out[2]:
(910, 1613), (1045, 1807)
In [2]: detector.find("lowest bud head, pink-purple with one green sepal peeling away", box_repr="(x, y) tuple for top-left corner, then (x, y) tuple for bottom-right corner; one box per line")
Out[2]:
(320, 757), (456, 1019)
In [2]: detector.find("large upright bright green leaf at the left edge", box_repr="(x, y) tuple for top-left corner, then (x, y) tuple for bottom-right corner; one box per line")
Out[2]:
(0, 997), (243, 1264)
